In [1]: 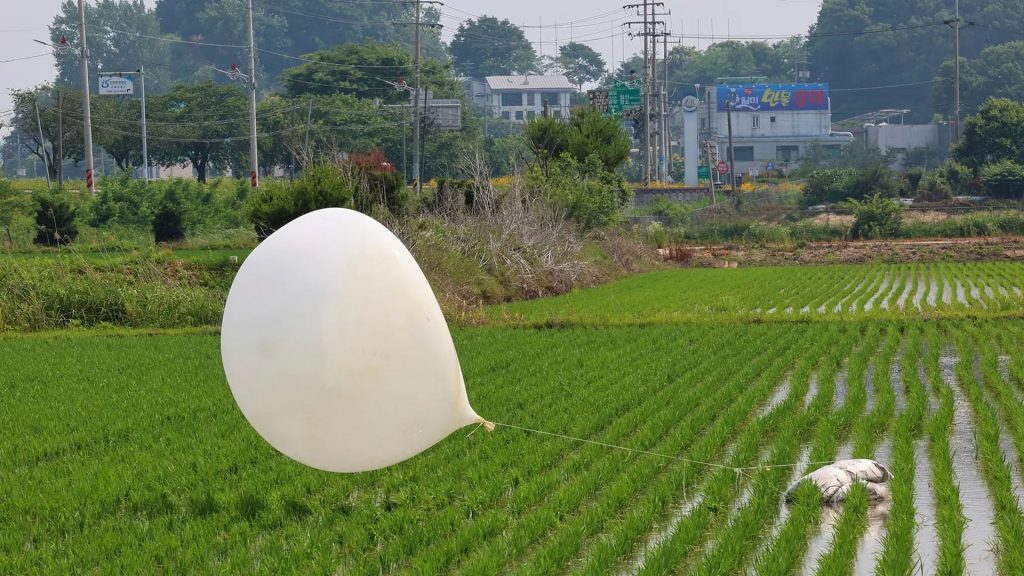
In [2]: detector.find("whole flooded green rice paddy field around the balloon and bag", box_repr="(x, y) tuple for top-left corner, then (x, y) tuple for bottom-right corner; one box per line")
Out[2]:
(0, 262), (1024, 576)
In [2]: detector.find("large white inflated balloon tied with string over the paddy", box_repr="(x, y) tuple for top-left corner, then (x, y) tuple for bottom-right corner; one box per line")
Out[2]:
(221, 208), (483, 472)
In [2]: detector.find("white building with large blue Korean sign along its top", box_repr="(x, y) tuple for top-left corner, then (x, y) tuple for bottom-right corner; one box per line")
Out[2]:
(686, 84), (853, 175)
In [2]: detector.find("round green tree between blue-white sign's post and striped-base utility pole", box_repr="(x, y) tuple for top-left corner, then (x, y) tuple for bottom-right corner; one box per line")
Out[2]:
(150, 82), (249, 182)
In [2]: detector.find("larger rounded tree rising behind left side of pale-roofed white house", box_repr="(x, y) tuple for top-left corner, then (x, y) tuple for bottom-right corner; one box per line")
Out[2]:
(449, 16), (537, 78)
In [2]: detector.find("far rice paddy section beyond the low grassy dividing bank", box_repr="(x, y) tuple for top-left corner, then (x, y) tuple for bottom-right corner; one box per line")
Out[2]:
(488, 262), (1024, 325)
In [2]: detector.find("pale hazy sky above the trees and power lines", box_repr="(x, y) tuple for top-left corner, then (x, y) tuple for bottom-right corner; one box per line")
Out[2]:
(0, 0), (820, 134)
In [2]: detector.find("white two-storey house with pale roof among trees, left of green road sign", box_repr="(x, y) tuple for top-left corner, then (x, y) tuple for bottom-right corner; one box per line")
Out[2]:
(479, 76), (575, 122)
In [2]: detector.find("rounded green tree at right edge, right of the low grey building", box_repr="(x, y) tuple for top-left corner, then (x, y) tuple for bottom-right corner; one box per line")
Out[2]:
(953, 98), (1024, 174)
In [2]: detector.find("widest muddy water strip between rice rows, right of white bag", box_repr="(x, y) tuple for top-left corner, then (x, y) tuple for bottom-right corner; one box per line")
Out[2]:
(939, 356), (995, 576)
